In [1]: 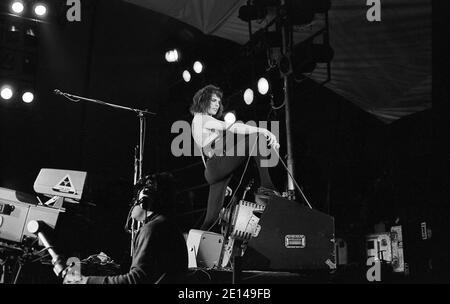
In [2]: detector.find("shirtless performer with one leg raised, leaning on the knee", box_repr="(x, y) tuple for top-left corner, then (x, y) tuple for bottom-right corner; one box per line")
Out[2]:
(190, 85), (279, 230)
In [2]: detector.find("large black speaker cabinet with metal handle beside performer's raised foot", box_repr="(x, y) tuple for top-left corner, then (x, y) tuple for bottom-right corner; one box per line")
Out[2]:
(242, 196), (336, 271)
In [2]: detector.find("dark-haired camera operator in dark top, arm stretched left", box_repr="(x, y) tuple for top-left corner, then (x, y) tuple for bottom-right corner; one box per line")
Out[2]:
(64, 173), (188, 284)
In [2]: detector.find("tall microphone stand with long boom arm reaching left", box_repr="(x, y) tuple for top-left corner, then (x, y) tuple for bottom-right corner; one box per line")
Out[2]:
(53, 89), (156, 256)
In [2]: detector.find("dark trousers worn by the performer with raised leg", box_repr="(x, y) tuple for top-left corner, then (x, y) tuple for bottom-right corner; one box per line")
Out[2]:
(200, 134), (275, 230)
